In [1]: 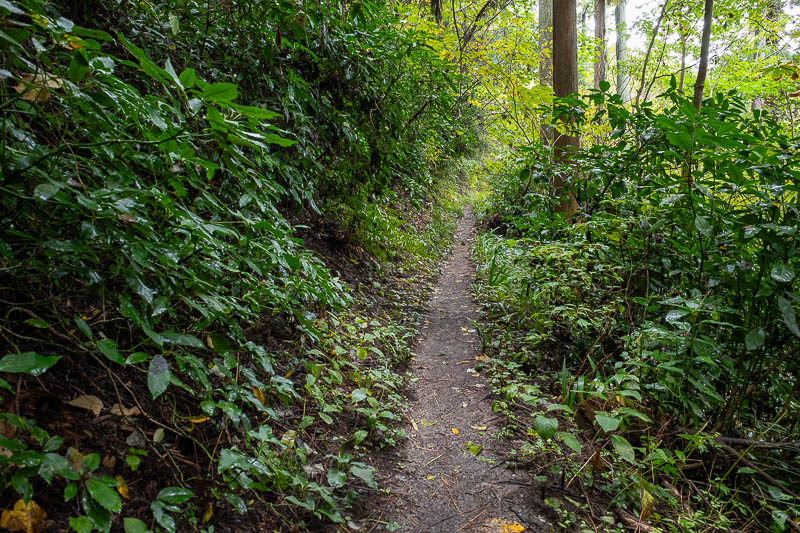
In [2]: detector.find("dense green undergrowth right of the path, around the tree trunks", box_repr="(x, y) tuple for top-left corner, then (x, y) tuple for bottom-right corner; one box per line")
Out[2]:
(476, 80), (800, 531)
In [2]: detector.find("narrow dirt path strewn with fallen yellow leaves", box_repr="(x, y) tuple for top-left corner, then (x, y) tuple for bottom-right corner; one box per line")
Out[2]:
(376, 208), (548, 532)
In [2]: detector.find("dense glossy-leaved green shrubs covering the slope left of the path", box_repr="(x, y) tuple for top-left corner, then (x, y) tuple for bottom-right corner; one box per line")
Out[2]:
(0, 0), (474, 531)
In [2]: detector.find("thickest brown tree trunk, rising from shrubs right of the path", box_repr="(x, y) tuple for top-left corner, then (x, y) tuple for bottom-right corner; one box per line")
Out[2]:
(550, 0), (580, 217)
